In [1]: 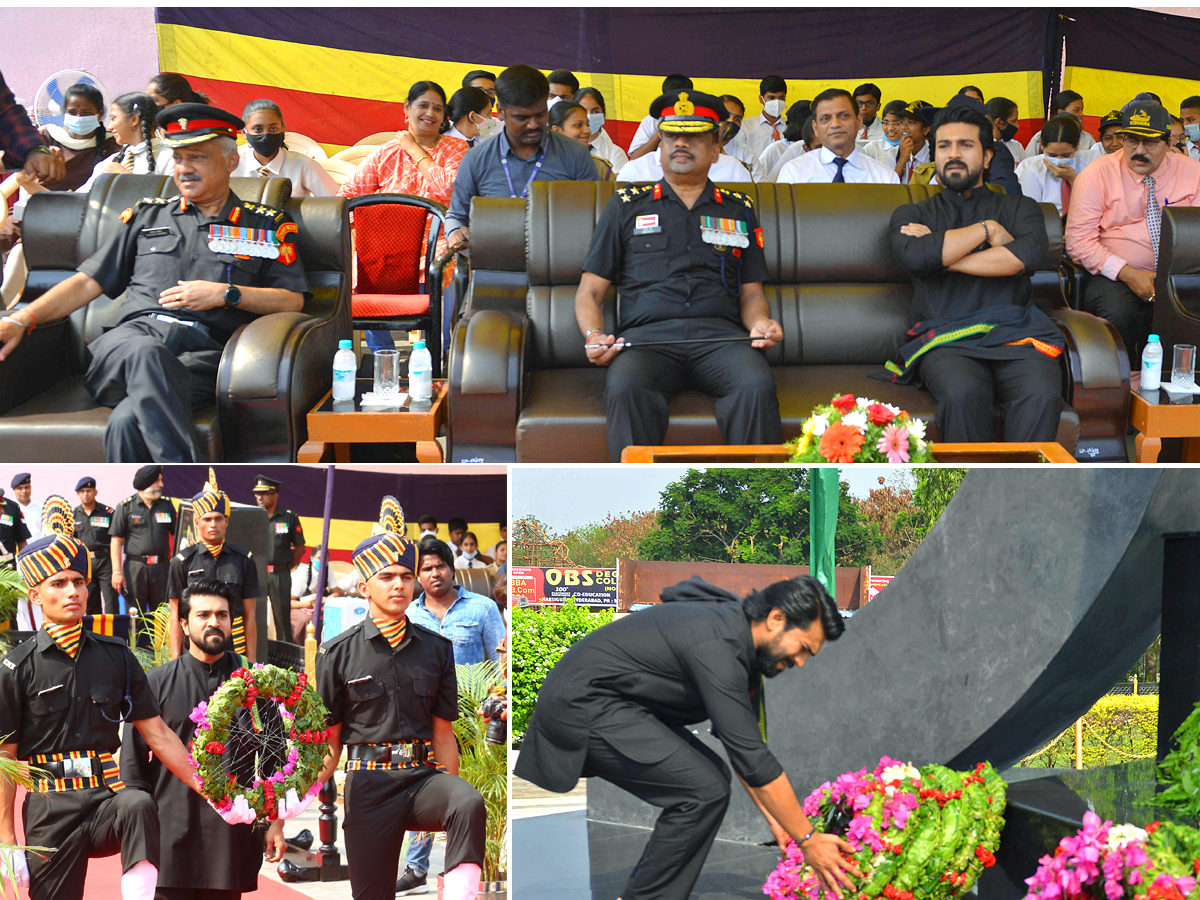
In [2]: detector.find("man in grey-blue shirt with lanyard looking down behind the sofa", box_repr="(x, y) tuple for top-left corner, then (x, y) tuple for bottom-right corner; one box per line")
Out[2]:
(446, 66), (600, 244)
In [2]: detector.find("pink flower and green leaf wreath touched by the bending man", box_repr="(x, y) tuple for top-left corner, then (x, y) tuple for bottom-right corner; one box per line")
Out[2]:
(762, 756), (1007, 900)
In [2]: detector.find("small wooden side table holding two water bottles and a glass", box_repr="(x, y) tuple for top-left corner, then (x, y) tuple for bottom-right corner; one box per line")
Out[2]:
(296, 378), (449, 462)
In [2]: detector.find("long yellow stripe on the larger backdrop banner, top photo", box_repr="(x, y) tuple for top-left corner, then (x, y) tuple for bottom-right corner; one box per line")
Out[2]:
(157, 24), (1041, 135)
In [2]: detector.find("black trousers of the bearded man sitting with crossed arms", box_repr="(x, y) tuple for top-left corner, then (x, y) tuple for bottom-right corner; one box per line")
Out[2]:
(920, 347), (1062, 443)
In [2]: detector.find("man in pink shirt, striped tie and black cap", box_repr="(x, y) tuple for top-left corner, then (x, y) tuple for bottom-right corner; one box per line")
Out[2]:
(1066, 101), (1200, 367)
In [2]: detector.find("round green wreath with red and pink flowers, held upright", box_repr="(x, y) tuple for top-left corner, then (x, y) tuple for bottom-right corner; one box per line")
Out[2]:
(187, 665), (329, 822)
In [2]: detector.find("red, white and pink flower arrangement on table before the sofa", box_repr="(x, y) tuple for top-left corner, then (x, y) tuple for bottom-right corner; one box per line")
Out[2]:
(788, 394), (934, 463)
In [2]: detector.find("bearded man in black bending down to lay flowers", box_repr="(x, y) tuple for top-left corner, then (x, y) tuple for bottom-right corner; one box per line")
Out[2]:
(514, 575), (858, 900)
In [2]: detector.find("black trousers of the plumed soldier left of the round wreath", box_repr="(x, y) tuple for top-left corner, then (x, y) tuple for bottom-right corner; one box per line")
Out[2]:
(22, 787), (160, 900)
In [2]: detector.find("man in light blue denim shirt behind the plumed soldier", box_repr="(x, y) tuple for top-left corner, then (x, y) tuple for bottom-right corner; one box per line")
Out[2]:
(396, 535), (504, 894)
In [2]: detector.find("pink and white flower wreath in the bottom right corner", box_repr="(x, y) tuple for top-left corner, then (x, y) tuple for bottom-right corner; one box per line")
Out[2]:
(1025, 811), (1200, 900)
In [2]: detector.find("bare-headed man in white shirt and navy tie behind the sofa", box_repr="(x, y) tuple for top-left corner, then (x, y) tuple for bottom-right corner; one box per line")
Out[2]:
(775, 88), (900, 185)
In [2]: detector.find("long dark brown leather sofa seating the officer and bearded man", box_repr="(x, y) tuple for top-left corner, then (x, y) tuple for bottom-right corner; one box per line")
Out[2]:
(449, 181), (1129, 462)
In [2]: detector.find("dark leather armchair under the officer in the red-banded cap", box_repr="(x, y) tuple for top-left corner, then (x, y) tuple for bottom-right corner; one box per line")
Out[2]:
(0, 175), (350, 462)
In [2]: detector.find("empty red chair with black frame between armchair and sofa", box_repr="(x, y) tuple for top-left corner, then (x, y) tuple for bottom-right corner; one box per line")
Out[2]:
(346, 193), (450, 378)
